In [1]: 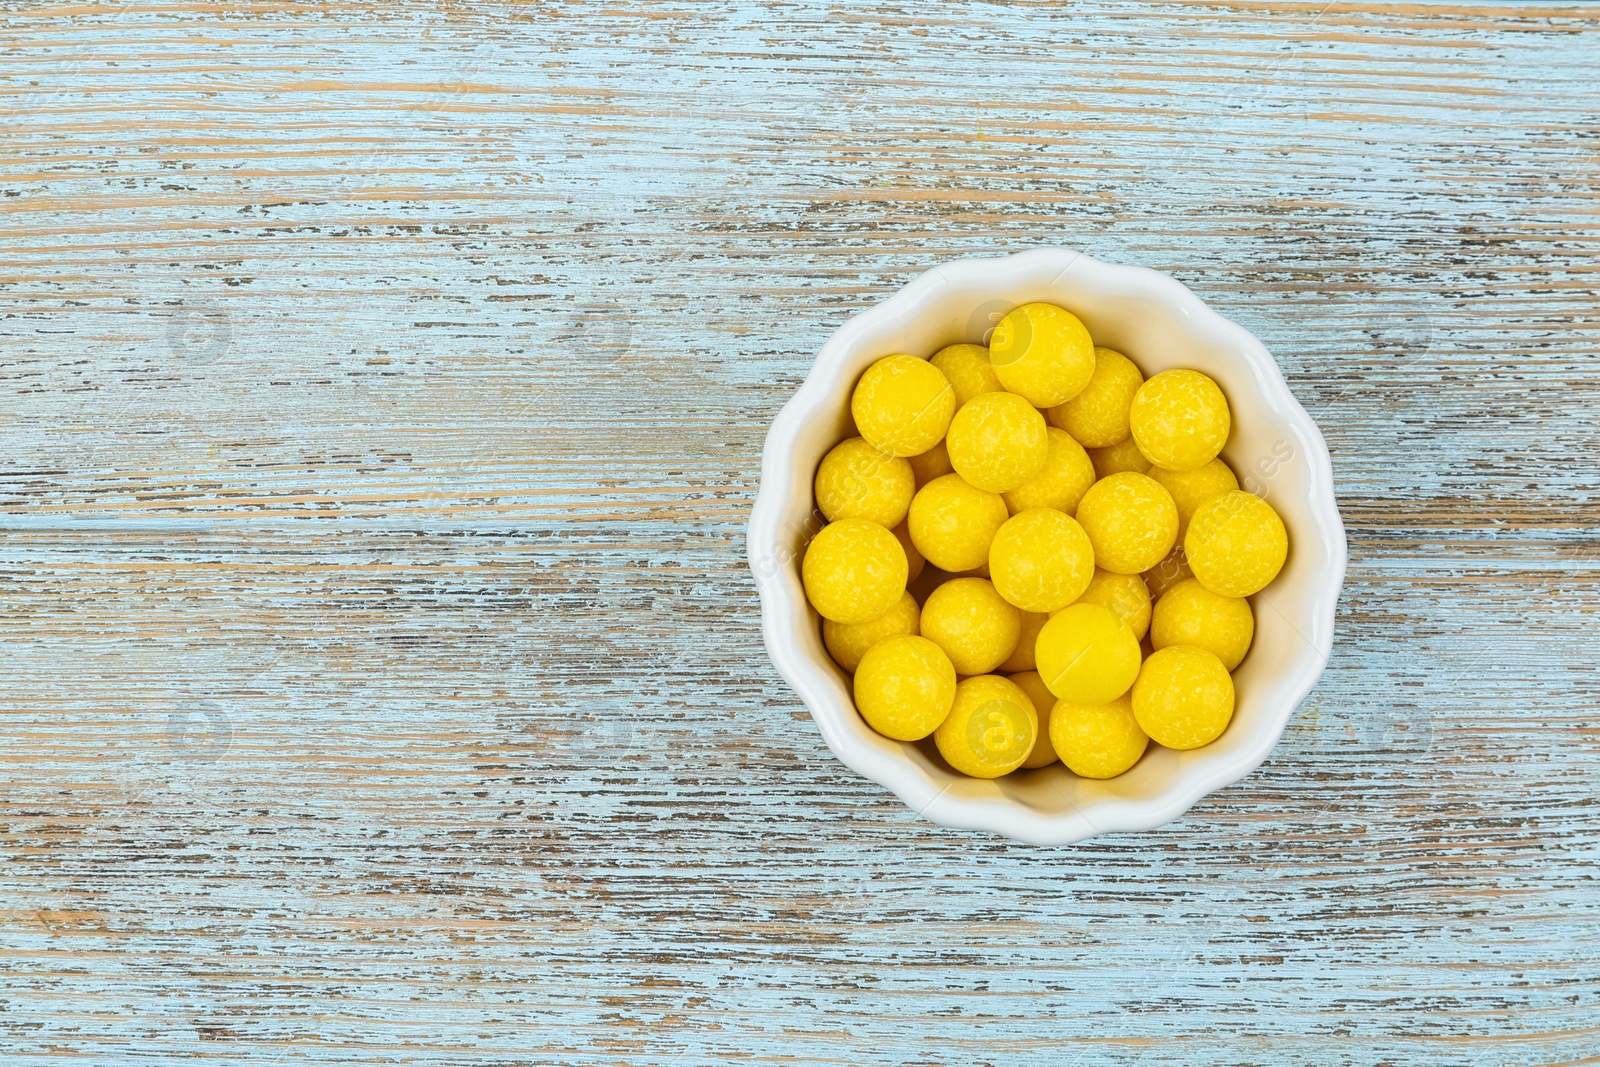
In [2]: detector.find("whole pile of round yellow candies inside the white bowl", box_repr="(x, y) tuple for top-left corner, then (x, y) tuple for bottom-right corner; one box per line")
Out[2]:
(800, 304), (1288, 777)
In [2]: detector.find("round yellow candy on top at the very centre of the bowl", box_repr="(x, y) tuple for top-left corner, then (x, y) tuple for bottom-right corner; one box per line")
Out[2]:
(989, 507), (1094, 613)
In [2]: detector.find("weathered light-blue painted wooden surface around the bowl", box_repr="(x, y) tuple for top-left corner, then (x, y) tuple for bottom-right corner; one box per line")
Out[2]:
(0, 0), (1600, 1067)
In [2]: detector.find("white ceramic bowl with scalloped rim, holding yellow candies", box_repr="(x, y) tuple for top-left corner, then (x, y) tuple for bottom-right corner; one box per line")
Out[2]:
(749, 248), (1346, 845)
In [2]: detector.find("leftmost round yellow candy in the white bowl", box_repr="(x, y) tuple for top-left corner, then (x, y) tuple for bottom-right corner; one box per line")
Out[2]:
(800, 518), (909, 622)
